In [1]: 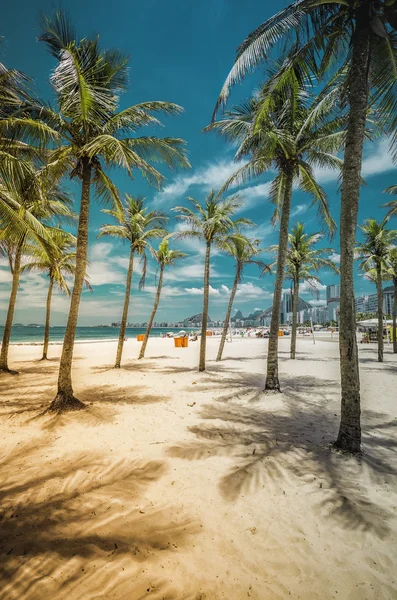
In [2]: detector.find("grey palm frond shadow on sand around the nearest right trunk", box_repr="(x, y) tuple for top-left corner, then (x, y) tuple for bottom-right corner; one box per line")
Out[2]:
(169, 376), (397, 537)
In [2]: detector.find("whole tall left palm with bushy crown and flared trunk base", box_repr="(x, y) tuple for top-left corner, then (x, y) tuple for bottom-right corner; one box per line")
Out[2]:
(0, 12), (190, 412)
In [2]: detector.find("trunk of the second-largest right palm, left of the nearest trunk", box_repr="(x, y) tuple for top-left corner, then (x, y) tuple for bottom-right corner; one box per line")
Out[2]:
(265, 167), (293, 392)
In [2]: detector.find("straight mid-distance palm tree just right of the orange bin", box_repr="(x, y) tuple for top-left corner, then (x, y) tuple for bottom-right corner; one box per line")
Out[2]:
(173, 190), (252, 371)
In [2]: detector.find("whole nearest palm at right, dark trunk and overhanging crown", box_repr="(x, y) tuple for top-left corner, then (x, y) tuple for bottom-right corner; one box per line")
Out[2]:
(210, 0), (397, 452)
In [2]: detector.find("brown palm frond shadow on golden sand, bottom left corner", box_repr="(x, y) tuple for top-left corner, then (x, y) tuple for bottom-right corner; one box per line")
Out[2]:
(0, 434), (199, 600)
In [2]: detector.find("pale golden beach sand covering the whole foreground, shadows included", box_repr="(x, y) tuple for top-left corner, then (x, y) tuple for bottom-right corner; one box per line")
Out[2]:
(0, 338), (397, 600)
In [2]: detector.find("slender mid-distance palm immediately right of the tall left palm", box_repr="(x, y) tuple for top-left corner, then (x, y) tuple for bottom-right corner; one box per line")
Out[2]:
(98, 194), (167, 369)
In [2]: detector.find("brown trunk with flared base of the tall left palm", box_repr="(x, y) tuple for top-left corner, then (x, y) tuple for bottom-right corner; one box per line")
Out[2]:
(48, 158), (91, 412)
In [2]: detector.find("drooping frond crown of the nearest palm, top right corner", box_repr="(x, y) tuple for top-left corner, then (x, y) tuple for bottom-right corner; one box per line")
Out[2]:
(214, 0), (397, 134)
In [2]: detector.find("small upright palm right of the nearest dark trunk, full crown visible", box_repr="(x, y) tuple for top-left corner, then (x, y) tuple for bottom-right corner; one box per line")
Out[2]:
(356, 218), (397, 362)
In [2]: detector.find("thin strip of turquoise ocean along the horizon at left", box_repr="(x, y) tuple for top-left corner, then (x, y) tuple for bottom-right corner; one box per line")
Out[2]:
(0, 325), (189, 344)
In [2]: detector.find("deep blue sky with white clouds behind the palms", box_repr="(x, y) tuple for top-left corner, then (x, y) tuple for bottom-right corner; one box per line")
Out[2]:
(0, 0), (397, 325)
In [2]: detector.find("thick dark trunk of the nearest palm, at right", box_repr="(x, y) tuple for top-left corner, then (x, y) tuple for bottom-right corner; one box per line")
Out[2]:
(335, 2), (370, 452)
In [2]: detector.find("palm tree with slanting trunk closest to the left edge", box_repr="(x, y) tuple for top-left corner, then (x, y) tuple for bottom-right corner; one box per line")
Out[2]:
(0, 170), (74, 373)
